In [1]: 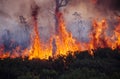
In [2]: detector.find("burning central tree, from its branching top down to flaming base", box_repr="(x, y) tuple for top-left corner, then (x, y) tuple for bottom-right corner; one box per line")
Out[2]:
(52, 0), (80, 56)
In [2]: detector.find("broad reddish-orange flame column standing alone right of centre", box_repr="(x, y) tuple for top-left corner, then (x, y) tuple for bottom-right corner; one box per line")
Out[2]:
(87, 19), (108, 55)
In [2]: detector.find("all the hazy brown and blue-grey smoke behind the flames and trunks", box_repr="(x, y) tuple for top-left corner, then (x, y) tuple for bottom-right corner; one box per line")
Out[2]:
(0, 0), (120, 47)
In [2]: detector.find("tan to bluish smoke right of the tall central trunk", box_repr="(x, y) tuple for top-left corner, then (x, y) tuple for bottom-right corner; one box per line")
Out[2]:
(61, 0), (120, 42)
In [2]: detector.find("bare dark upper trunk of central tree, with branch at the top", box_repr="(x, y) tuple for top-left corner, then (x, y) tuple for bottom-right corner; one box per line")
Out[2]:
(55, 0), (70, 33)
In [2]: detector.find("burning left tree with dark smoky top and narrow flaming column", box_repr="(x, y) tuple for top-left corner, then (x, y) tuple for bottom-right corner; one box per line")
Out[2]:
(28, 4), (52, 59)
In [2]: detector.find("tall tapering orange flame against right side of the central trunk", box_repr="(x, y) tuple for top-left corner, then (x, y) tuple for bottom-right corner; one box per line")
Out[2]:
(55, 13), (80, 55)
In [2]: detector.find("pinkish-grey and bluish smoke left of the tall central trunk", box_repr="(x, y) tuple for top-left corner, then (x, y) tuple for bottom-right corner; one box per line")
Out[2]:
(0, 0), (54, 47)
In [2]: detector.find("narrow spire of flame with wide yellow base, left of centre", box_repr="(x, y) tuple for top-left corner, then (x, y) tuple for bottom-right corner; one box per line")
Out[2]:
(29, 15), (52, 59)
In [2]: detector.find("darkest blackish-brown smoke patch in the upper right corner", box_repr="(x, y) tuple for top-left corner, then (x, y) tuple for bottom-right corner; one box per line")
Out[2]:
(91, 0), (120, 16)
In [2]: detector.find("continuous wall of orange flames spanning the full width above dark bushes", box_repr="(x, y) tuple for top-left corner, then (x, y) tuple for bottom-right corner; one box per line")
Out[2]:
(0, 13), (120, 60)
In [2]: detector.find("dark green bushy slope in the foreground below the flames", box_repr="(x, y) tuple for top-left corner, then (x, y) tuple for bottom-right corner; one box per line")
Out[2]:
(0, 48), (120, 79)
